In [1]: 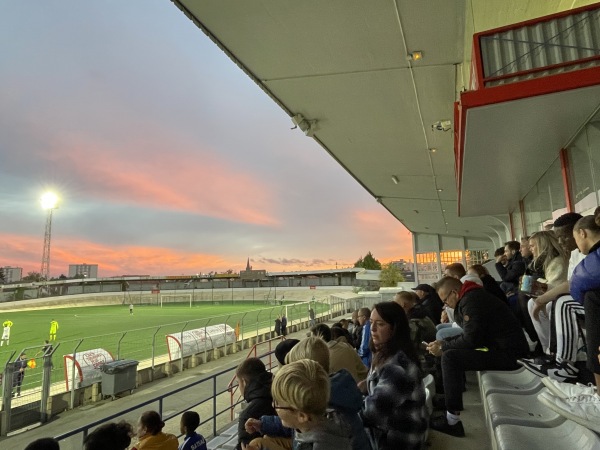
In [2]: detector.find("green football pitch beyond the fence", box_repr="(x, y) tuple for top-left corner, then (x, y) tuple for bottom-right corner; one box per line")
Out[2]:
(0, 301), (328, 384)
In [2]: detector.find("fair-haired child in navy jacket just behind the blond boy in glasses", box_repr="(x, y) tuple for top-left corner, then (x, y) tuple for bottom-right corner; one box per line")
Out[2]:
(286, 336), (370, 450)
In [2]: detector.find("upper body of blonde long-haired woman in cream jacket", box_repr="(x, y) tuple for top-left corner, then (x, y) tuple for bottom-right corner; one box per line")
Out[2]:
(528, 231), (569, 288)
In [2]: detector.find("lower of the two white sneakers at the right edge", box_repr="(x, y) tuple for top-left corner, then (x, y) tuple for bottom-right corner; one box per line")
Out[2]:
(538, 391), (600, 433)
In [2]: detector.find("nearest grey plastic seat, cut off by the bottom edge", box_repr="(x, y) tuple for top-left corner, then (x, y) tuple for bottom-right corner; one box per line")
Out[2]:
(493, 420), (600, 450)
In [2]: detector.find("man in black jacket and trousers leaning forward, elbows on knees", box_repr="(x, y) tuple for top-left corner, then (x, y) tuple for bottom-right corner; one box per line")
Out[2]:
(427, 277), (529, 437)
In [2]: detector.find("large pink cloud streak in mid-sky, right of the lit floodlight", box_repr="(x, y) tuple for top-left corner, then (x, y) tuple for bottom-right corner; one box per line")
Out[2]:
(35, 128), (279, 226)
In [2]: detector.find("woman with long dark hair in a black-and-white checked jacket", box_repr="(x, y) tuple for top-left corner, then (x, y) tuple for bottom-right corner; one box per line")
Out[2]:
(359, 302), (427, 450)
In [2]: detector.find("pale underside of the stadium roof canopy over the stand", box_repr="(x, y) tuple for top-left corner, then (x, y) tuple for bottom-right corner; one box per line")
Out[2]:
(173, 0), (593, 243)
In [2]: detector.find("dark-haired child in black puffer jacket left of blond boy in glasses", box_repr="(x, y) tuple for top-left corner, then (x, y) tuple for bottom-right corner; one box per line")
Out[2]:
(235, 358), (275, 450)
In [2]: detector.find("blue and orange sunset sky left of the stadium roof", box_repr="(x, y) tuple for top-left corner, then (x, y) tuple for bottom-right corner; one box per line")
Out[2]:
(0, 0), (412, 276)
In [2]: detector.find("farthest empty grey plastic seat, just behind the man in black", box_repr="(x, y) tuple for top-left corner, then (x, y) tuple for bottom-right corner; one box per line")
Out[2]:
(479, 368), (544, 401)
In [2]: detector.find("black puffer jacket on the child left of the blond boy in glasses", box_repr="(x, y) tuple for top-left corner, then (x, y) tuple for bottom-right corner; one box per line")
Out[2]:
(236, 372), (276, 450)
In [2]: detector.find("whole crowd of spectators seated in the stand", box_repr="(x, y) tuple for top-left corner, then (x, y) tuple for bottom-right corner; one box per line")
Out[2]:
(21, 208), (600, 450)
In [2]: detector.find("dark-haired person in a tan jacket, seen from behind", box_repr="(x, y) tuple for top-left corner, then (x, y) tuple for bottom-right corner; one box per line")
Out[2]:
(310, 323), (368, 383)
